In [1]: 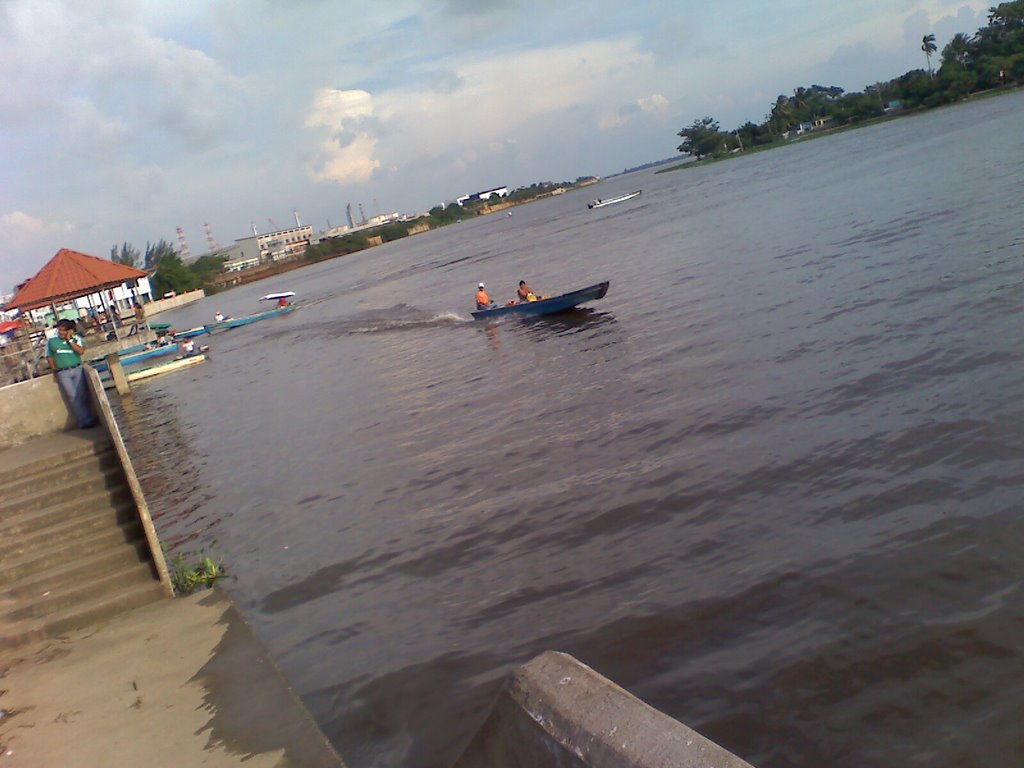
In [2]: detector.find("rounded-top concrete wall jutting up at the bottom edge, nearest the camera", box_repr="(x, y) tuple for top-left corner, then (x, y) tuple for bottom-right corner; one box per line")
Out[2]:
(454, 651), (751, 768)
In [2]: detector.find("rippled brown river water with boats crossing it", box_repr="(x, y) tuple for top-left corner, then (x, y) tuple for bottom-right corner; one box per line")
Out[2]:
(120, 93), (1024, 768)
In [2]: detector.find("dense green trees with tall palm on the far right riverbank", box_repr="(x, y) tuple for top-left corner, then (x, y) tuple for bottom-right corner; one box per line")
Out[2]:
(677, 0), (1024, 160)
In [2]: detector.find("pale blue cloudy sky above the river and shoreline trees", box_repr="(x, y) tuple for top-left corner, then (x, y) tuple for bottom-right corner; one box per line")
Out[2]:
(0, 0), (992, 295)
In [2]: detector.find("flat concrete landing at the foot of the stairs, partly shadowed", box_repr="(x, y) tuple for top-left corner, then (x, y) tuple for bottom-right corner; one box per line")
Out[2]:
(0, 589), (344, 768)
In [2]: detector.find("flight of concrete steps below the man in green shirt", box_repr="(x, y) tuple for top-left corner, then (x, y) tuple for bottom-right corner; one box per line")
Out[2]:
(0, 430), (166, 650)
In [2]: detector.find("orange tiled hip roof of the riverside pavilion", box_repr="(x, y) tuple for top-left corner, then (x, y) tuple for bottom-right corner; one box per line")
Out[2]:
(6, 248), (147, 309)
